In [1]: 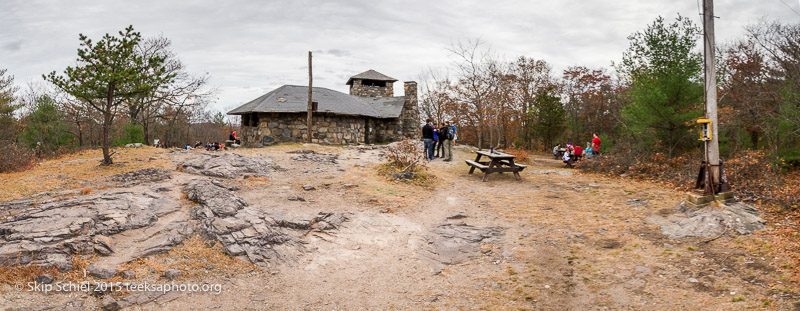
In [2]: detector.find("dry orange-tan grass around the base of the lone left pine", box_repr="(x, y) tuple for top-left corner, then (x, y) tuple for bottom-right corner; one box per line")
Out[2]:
(0, 147), (172, 202)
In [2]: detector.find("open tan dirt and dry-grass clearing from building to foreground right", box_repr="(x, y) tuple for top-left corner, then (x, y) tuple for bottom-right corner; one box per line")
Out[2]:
(1, 146), (800, 310)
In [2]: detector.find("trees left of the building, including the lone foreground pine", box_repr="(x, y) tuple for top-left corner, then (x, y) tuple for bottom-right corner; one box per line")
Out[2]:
(0, 27), (230, 172)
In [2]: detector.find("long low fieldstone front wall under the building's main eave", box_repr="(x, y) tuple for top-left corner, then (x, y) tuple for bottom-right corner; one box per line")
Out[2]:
(240, 113), (366, 147)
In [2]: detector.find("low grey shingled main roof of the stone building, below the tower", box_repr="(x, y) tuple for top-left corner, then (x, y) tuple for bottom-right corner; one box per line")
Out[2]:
(228, 85), (405, 118)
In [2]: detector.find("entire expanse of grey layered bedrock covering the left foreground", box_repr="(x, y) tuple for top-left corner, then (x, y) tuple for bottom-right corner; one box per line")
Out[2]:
(0, 160), (347, 279)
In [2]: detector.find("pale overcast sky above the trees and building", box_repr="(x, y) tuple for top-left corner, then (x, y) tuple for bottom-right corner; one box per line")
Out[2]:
(0, 0), (800, 111)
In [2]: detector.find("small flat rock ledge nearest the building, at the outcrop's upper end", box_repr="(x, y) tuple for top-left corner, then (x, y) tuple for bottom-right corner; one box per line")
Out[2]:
(178, 152), (275, 179)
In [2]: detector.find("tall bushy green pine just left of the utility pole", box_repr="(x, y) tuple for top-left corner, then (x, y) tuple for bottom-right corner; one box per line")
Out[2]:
(618, 15), (703, 157)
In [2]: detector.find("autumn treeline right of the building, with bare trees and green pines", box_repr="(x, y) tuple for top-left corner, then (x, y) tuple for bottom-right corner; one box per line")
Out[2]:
(421, 16), (800, 165)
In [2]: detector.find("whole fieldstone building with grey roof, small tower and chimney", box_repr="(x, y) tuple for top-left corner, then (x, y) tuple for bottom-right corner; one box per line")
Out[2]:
(228, 70), (420, 147)
